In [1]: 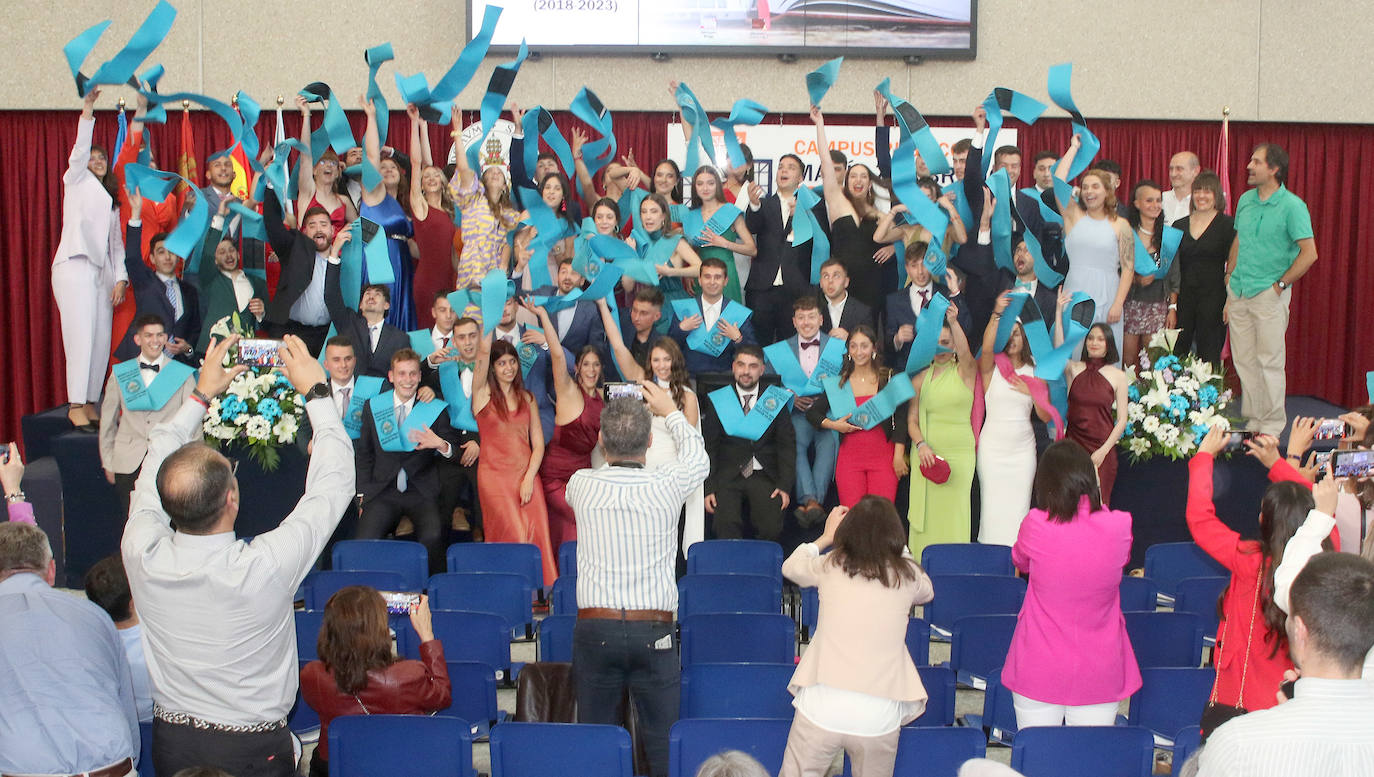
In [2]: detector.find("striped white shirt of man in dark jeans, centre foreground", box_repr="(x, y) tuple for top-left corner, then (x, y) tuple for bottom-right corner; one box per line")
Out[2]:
(567, 410), (710, 611)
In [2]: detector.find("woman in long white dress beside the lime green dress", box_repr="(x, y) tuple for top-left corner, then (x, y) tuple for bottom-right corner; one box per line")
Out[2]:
(977, 292), (1062, 545)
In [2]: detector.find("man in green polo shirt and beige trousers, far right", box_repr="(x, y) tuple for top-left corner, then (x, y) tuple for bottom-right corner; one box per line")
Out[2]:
(1226, 143), (1316, 437)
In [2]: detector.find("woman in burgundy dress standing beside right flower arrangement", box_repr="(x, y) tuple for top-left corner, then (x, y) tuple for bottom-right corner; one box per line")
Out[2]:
(1054, 291), (1131, 505)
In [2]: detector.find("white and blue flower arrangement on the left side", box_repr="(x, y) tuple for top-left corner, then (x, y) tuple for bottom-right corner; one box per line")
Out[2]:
(202, 313), (305, 472)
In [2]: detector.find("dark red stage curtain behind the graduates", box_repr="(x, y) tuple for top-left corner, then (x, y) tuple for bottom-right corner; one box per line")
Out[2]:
(0, 111), (1374, 441)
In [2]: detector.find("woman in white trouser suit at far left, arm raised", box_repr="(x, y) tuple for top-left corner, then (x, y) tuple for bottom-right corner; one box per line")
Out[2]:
(52, 88), (129, 428)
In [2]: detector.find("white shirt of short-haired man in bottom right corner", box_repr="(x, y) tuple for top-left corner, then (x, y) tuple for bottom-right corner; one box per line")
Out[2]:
(1198, 677), (1374, 777)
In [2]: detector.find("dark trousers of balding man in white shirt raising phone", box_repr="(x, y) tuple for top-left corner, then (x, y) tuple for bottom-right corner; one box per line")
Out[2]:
(153, 719), (295, 777)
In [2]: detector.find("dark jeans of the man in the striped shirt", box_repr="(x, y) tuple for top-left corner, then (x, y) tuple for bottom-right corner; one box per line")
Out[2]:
(573, 618), (682, 777)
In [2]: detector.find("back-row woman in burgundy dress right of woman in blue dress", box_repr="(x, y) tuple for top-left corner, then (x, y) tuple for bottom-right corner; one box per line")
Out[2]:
(405, 106), (458, 329)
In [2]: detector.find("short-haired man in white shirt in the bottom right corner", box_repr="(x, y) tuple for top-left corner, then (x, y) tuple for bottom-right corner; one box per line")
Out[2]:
(1198, 553), (1374, 777)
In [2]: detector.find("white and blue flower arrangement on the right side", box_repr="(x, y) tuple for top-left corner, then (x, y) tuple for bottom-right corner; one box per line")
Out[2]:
(1118, 329), (1231, 461)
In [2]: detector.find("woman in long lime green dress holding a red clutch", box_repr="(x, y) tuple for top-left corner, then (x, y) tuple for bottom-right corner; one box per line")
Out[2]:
(907, 305), (978, 559)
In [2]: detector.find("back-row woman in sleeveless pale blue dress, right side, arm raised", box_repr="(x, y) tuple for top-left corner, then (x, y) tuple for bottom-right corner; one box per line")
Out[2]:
(1054, 135), (1135, 367)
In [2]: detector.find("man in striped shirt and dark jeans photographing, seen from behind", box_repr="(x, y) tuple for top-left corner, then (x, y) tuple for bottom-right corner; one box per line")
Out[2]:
(567, 382), (710, 777)
